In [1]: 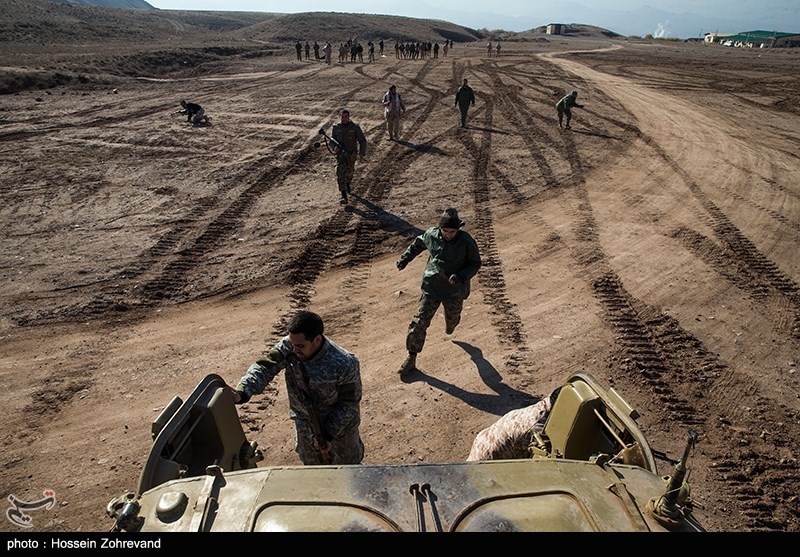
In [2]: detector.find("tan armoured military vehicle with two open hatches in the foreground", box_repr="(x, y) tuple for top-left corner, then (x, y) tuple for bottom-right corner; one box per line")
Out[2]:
(106, 372), (703, 532)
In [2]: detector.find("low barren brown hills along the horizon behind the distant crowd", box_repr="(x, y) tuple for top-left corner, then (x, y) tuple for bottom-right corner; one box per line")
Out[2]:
(0, 0), (616, 46)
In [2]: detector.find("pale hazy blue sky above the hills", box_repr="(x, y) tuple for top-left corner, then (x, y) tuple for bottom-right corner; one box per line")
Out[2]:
(146, 0), (800, 38)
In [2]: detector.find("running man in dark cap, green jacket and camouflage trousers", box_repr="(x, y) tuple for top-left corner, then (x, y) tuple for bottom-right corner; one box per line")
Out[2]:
(397, 208), (481, 374)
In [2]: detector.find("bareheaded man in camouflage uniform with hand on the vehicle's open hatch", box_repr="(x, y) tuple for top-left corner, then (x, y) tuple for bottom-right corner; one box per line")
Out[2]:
(227, 311), (364, 465)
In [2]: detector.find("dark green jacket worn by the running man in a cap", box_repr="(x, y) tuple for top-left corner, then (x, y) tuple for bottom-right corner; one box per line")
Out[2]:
(399, 226), (481, 300)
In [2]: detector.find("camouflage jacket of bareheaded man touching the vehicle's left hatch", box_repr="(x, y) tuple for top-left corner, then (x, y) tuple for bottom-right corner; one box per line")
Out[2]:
(236, 336), (361, 440)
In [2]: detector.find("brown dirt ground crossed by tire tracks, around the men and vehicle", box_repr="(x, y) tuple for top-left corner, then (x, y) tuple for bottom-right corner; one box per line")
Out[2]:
(0, 33), (800, 532)
